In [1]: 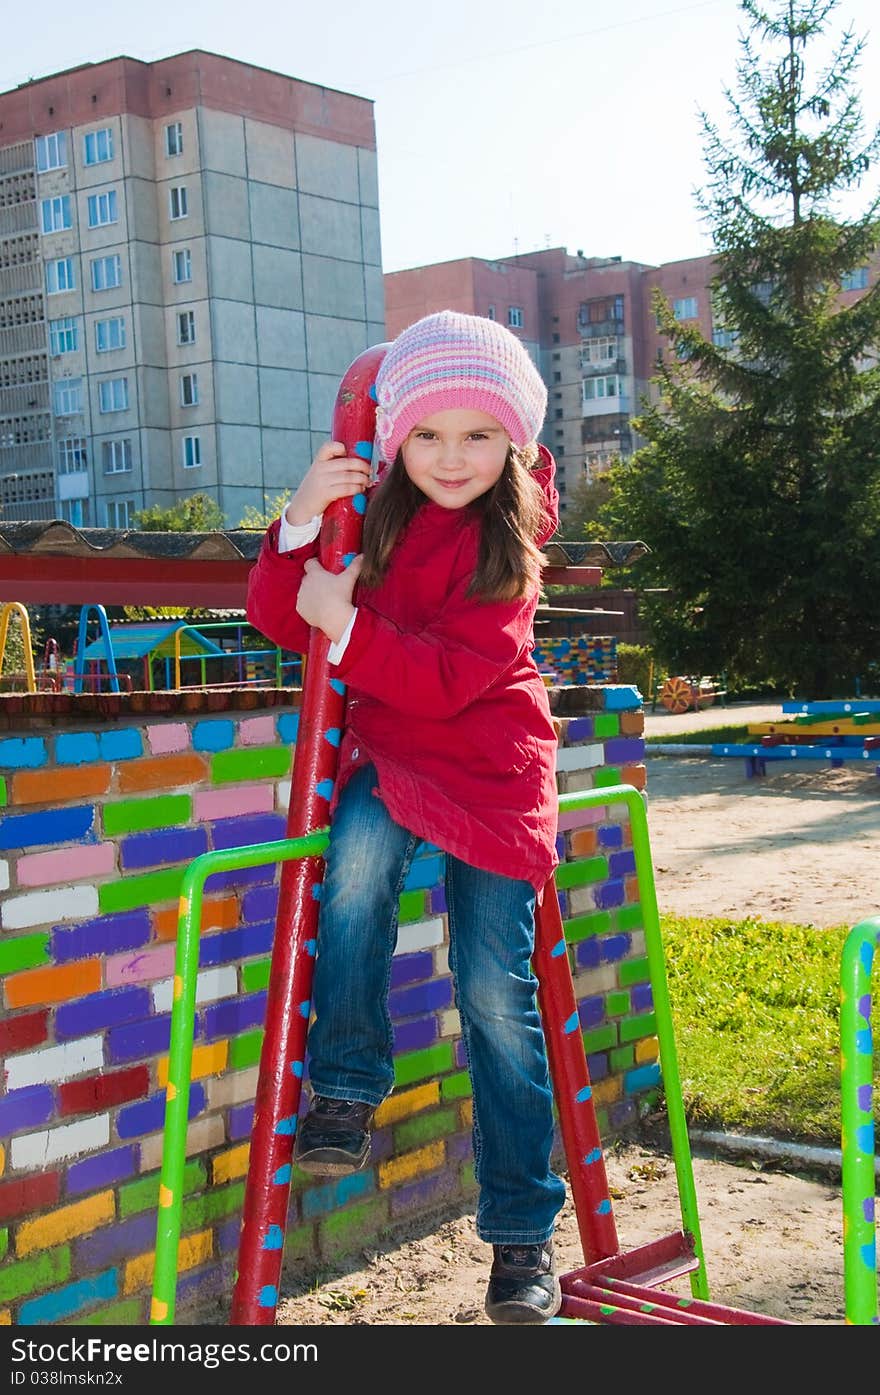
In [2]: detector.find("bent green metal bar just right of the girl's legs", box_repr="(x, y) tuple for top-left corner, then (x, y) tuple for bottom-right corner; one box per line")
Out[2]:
(559, 785), (708, 1299)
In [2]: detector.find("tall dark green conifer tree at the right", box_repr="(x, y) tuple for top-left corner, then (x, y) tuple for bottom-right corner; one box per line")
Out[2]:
(591, 0), (880, 698)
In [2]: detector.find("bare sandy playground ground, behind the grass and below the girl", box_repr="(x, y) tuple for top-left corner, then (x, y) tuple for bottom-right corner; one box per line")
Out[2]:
(278, 703), (880, 1325)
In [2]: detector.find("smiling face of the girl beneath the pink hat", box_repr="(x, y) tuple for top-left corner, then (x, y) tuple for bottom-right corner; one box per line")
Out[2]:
(402, 407), (510, 509)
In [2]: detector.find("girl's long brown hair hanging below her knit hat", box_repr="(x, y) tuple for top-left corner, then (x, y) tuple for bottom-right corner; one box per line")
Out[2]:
(360, 445), (544, 601)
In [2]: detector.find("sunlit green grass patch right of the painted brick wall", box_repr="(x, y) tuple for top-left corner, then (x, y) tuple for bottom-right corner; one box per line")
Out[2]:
(661, 915), (880, 1148)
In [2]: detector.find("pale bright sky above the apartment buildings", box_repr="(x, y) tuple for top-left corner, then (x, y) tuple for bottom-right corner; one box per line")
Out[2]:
(0, 0), (880, 272)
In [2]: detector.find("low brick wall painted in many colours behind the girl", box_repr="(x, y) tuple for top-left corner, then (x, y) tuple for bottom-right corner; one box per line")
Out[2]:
(0, 686), (658, 1325)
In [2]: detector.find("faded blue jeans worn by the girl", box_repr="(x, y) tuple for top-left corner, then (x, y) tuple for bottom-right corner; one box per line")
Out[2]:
(308, 766), (565, 1244)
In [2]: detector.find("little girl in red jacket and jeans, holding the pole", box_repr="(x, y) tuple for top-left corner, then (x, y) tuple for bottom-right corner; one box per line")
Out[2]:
(247, 311), (565, 1322)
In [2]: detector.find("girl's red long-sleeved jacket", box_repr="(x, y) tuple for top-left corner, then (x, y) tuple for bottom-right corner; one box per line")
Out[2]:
(247, 446), (559, 891)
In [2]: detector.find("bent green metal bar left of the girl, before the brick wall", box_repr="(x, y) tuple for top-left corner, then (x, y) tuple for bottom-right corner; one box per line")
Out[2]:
(149, 829), (328, 1327)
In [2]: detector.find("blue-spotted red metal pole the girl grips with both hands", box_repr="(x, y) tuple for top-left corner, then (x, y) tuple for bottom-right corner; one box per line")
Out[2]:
(232, 345), (388, 1327)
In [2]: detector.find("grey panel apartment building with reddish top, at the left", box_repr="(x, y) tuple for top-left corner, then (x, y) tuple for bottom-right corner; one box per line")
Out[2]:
(0, 50), (385, 529)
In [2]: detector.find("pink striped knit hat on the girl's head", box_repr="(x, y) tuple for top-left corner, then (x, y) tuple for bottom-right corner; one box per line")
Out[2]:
(375, 310), (547, 465)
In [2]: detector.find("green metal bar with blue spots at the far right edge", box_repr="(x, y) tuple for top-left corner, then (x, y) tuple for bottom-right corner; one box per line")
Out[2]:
(840, 917), (880, 1325)
